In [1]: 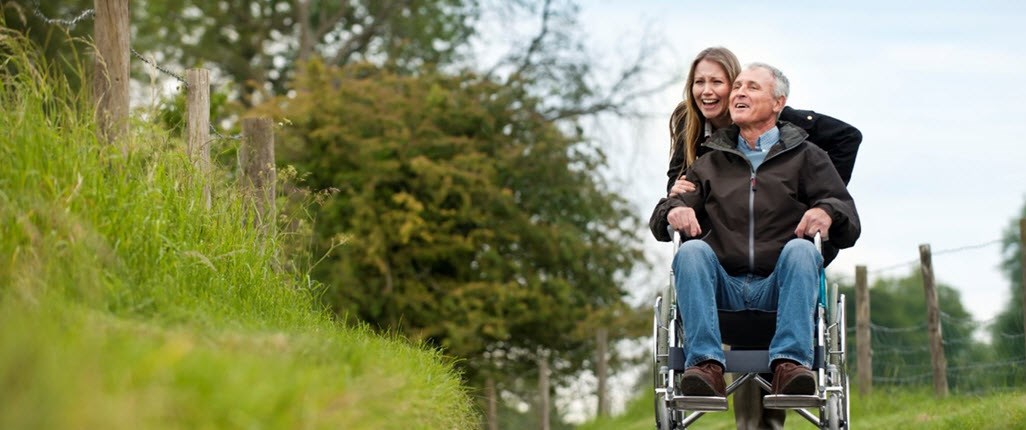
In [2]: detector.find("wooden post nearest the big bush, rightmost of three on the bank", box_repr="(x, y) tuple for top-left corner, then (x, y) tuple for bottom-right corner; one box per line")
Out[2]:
(239, 118), (277, 234)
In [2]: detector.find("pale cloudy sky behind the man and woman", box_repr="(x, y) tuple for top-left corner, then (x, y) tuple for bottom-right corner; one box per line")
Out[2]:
(580, 0), (1026, 320)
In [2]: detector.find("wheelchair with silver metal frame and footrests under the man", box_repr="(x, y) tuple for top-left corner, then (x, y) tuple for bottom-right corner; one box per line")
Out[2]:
(652, 232), (851, 430)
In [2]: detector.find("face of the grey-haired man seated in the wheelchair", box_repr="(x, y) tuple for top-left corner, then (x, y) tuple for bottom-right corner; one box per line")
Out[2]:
(731, 68), (786, 127)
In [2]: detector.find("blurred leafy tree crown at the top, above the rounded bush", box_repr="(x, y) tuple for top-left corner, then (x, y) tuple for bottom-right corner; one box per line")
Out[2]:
(132, 0), (476, 105)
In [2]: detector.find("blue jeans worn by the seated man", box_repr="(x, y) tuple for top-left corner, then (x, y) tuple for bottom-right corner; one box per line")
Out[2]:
(673, 239), (823, 367)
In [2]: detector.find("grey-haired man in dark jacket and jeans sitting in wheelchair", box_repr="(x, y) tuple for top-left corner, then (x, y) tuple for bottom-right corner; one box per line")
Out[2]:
(649, 64), (860, 396)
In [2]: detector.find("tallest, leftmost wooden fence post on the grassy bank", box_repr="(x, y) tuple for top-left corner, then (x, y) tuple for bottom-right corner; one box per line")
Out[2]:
(92, 0), (130, 149)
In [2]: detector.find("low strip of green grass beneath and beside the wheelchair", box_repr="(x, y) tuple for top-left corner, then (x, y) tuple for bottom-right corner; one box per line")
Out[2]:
(578, 389), (1026, 430)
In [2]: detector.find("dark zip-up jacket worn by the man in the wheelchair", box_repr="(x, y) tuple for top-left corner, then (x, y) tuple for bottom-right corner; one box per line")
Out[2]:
(648, 122), (861, 276)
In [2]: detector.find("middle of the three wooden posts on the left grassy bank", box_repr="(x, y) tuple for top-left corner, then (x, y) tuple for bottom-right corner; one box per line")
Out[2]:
(186, 69), (212, 209)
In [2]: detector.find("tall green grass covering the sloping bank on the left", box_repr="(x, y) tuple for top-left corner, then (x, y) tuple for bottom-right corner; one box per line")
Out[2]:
(0, 28), (478, 429)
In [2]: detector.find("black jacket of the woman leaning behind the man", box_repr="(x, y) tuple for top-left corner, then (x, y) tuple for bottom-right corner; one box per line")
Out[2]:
(666, 106), (862, 192)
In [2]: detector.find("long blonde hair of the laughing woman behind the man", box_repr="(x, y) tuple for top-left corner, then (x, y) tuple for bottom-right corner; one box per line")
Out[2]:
(670, 46), (741, 178)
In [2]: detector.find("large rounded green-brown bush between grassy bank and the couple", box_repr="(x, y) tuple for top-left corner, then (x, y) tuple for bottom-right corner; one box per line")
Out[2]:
(266, 62), (640, 385)
